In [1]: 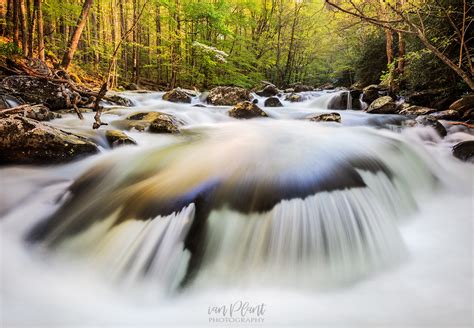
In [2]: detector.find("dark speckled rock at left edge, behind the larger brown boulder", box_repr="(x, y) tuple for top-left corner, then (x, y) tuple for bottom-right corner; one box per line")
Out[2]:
(0, 75), (73, 110)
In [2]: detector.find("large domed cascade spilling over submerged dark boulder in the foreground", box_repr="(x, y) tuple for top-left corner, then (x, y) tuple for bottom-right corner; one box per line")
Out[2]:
(19, 121), (435, 292)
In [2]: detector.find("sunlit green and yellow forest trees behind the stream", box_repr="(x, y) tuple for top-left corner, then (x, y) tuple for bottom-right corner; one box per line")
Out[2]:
(0, 0), (474, 92)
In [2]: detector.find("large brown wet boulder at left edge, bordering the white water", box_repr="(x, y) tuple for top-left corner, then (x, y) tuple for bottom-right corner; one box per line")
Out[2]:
(0, 115), (98, 164)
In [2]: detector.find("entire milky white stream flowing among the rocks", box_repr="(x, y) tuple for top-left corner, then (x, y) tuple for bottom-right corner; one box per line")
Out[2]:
(0, 92), (474, 327)
